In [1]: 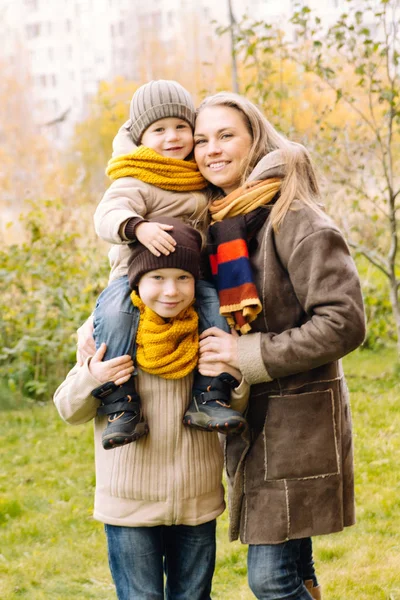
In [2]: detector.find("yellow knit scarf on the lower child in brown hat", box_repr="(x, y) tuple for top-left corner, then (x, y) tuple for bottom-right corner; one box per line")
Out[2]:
(131, 292), (199, 379)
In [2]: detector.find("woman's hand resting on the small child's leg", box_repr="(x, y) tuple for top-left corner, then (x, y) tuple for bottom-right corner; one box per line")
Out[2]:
(198, 327), (242, 381)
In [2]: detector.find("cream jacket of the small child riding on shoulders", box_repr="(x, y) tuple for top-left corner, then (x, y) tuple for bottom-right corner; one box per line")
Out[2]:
(94, 177), (208, 281)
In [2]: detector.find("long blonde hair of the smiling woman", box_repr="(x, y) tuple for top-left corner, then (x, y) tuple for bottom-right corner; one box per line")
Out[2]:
(197, 92), (322, 231)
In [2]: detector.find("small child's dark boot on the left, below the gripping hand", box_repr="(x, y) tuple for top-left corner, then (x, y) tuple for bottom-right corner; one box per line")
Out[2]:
(92, 381), (149, 450)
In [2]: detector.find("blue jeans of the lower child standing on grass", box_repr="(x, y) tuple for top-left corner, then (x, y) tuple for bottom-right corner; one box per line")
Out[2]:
(105, 519), (216, 600)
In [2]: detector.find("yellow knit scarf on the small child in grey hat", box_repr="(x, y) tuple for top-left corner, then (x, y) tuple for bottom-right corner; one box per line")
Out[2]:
(106, 146), (208, 192)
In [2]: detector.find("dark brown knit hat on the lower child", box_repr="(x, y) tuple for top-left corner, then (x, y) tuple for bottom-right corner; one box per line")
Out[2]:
(128, 217), (202, 289)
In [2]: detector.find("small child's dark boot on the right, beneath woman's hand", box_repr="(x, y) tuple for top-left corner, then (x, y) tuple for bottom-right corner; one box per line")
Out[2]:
(183, 373), (246, 435)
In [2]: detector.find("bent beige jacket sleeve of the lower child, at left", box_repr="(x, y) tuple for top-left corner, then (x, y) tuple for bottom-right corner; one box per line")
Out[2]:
(53, 359), (101, 425)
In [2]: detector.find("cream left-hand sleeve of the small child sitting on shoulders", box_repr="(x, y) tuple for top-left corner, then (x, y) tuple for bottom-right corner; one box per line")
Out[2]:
(94, 177), (149, 244)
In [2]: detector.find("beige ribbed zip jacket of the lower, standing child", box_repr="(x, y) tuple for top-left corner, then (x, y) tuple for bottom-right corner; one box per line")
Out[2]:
(54, 359), (249, 527)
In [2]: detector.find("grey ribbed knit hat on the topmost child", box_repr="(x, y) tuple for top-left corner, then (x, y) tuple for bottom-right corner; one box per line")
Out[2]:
(127, 79), (195, 145)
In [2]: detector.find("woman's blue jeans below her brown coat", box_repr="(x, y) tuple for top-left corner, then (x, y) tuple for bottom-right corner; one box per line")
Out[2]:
(247, 538), (318, 600)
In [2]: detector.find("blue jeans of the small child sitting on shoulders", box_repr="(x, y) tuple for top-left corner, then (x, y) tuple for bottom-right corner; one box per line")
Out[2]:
(94, 275), (229, 392)
